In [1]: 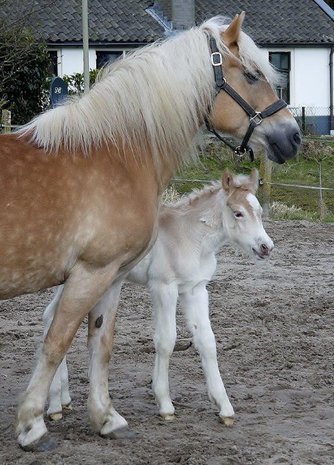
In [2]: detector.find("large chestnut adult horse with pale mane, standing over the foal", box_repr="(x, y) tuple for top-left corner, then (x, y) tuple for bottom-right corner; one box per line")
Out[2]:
(0, 14), (300, 449)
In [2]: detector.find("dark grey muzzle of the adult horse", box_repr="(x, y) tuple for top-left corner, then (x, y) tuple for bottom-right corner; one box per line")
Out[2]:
(267, 125), (302, 164)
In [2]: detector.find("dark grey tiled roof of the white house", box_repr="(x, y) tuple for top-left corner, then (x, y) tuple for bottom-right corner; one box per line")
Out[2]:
(0, 0), (334, 45)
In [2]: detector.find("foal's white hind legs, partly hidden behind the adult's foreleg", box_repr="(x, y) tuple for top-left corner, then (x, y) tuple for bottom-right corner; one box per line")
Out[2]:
(43, 286), (71, 420)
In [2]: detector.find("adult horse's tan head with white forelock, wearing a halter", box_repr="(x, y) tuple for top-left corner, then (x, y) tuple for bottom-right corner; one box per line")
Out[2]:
(203, 12), (301, 163)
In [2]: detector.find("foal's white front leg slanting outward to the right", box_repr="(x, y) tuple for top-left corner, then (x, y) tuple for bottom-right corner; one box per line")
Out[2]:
(180, 283), (234, 425)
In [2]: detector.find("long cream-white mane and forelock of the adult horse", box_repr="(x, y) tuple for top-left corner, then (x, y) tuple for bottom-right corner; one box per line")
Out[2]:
(18, 17), (275, 172)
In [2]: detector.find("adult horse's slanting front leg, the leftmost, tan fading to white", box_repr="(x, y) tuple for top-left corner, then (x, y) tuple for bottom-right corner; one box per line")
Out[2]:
(17, 265), (118, 450)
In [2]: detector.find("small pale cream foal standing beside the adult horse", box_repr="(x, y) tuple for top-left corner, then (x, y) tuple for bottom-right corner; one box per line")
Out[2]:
(44, 170), (273, 425)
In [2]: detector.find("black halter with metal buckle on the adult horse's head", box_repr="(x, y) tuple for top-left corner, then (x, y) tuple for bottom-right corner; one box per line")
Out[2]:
(205, 37), (287, 161)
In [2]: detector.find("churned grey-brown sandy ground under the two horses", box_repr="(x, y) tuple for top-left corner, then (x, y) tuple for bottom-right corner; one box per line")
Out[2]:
(0, 222), (334, 465)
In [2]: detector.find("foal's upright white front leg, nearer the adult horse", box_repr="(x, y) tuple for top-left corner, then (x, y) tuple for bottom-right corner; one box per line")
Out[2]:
(151, 283), (178, 420)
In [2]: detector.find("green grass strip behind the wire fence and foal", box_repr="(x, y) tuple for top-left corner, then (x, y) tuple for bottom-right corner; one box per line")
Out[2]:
(172, 138), (334, 223)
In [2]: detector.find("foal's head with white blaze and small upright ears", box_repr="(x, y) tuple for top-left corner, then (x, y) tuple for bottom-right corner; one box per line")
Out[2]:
(222, 169), (274, 259)
